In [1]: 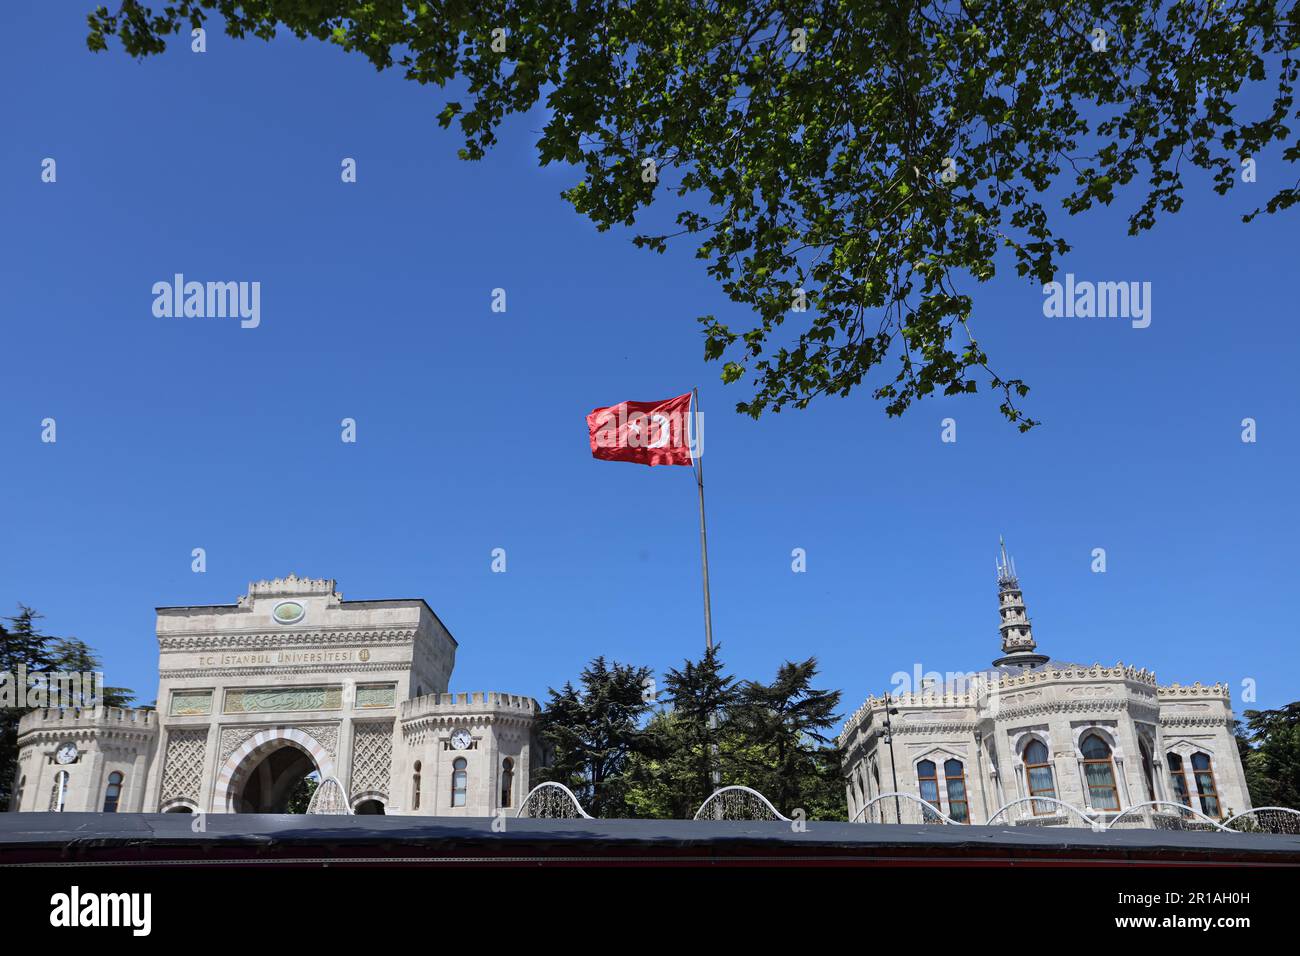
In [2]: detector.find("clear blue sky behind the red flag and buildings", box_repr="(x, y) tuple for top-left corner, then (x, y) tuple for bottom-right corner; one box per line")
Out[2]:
(0, 9), (1300, 714)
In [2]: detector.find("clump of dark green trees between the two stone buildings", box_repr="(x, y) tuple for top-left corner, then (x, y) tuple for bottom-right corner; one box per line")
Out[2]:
(546, 646), (845, 819)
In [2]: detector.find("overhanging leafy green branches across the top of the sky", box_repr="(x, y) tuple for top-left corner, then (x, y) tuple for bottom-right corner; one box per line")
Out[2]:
(87, 0), (1300, 431)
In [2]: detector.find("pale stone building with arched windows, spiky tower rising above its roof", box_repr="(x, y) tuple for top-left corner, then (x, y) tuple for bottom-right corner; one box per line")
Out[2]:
(839, 546), (1251, 826)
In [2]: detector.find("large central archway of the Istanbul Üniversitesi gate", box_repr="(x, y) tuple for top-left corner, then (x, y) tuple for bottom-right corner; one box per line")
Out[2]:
(213, 727), (334, 813)
